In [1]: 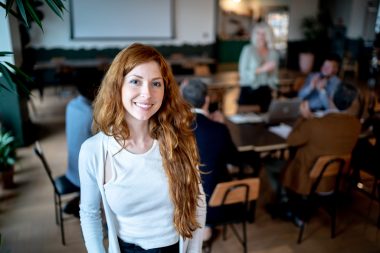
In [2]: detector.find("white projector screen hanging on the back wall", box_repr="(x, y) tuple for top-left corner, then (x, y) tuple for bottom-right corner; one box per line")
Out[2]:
(70, 0), (174, 40)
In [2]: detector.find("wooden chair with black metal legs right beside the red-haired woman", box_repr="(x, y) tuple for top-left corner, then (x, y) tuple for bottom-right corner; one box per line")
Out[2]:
(209, 178), (260, 253)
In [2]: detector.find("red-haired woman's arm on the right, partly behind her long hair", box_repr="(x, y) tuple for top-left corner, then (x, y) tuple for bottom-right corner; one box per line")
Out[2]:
(185, 184), (206, 253)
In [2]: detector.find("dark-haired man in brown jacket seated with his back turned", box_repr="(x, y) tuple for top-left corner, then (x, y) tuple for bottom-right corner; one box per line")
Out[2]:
(268, 83), (361, 216)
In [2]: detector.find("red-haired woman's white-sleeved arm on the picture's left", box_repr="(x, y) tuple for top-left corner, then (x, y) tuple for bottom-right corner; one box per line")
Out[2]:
(79, 141), (106, 253)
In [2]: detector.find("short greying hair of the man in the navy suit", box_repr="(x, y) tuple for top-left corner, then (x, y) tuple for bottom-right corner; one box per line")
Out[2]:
(182, 79), (207, 108)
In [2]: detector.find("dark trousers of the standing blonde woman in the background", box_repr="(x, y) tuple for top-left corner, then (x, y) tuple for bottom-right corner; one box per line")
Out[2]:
(238, 86), (272, 112)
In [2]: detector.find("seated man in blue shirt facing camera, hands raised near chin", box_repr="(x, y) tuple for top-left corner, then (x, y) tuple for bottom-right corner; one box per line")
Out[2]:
(298, 55), (340, 112)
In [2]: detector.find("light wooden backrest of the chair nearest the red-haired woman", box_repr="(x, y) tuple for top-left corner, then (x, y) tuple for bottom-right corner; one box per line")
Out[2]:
(209, 178), (260, 207)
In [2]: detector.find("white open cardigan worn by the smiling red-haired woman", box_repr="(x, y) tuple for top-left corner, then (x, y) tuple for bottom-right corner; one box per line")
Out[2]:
(79, 132), (206, 253)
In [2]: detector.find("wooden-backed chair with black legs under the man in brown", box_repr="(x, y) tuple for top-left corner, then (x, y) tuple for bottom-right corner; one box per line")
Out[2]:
(297, 154), (351, 243)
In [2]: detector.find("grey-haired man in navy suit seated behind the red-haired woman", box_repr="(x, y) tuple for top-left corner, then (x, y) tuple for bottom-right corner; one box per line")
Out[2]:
(181, 79), (243, 240)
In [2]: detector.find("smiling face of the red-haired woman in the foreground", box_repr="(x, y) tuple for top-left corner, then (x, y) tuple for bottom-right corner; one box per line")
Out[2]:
(121, 61), (165, 122)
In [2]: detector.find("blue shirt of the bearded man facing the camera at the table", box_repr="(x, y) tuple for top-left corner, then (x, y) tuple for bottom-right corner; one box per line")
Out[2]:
(298, 73), (340, 111)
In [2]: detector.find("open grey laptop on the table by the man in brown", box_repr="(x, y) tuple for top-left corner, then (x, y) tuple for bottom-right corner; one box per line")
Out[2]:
(261, 98), (302, 125)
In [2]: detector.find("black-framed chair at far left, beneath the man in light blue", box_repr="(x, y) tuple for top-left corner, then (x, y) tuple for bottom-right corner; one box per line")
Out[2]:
(34, 141), (80, 245)
